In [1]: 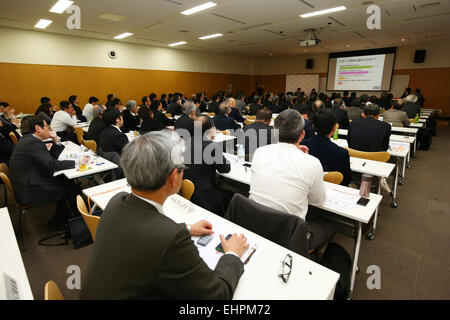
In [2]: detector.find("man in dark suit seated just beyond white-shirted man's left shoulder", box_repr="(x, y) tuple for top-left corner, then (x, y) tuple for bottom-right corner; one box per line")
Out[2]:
(243, 108), (275, 155)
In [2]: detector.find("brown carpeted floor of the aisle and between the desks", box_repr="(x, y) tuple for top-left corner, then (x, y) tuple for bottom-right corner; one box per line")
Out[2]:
(1, 126), (450, 300)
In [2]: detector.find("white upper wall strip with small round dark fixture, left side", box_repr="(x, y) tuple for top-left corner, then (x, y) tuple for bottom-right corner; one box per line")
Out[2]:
(0, 28), (255, 75)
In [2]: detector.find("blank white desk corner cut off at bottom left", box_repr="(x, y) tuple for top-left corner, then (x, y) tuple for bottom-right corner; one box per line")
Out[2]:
(0, 207), (33, 300)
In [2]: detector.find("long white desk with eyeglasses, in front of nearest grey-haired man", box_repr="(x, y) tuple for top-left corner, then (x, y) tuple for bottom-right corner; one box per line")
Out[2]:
(83, 179), (339, 300)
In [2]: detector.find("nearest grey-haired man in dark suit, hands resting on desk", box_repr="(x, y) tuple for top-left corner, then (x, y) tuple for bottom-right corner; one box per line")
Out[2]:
(80, 131), (248, 300)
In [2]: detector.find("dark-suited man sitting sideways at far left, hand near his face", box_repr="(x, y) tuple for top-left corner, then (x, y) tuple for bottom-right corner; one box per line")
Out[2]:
(9, 116), (83, 222)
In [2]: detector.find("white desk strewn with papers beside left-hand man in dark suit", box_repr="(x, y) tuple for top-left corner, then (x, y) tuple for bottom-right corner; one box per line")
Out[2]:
(53, 141), (117, 179)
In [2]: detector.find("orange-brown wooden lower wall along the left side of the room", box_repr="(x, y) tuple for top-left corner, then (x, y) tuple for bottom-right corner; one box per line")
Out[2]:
(0, 63), (254, 113)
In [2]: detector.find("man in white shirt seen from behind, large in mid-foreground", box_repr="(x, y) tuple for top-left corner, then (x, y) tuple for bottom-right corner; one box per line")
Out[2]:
(249, 109), (334, 248)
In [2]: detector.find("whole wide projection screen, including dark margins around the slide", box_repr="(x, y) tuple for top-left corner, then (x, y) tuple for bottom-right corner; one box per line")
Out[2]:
(327, 48), (396, 91)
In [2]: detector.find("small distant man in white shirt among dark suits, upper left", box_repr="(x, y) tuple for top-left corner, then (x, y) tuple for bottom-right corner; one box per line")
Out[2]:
(50, 101), (78, 144)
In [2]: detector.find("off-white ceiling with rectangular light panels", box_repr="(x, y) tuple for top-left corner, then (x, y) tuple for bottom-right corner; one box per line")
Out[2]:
(0, 0), (450, 57)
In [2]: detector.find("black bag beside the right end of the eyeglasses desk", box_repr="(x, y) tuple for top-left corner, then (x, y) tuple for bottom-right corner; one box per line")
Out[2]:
(319, 242), (352, 300)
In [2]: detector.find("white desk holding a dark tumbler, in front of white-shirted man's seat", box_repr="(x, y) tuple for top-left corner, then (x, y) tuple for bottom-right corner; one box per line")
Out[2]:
(218, 154), (383, 296)
